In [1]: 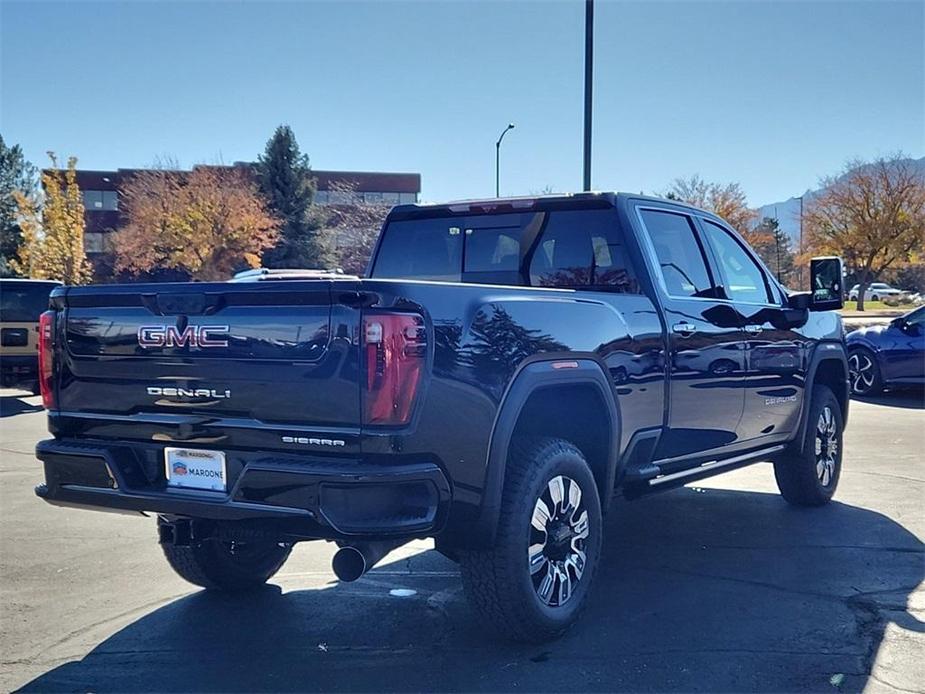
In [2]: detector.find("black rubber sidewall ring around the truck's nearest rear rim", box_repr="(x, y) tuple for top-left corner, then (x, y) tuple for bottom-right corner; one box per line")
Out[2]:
(508, 451), (602, 631)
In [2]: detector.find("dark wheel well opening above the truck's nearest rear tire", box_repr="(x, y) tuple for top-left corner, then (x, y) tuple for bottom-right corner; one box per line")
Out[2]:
(512, 384), (615, 505)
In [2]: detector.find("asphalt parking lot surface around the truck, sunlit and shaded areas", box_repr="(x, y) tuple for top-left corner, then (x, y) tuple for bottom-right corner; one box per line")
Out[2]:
(0, 390), (925, 692)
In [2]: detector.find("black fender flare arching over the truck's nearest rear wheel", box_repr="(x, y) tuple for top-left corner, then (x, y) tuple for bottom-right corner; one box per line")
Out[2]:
(474, 357), (621, 546)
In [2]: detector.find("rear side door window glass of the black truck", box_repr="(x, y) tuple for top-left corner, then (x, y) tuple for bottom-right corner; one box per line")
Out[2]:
(640, 210), (715, 297)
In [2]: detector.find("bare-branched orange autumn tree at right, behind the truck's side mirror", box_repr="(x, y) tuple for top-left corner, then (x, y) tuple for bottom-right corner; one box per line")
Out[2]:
(803, 155), (925, 311)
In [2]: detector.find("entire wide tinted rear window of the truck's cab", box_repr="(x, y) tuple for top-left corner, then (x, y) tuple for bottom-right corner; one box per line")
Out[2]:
(370, 208), (641, 294)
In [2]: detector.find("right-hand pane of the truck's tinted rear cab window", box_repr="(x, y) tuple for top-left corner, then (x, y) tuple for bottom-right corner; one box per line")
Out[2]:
(530, 210), (640, 294)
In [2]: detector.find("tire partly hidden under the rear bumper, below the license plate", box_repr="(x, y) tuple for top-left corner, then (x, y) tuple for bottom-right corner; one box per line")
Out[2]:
(161, 524), (292, 591)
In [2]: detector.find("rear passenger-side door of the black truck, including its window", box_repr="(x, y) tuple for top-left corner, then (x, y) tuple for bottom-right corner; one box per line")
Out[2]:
(636, 207), (745, 461)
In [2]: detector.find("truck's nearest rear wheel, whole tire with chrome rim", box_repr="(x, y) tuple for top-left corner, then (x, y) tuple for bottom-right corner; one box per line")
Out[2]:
(459, 438), (602, 642)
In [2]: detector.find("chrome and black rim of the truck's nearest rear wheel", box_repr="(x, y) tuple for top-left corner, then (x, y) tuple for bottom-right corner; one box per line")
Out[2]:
(527, 475), (590, 607)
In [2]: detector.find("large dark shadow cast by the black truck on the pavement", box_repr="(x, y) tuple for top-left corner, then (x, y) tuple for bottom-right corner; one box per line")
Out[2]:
(23, 488), (925, 692)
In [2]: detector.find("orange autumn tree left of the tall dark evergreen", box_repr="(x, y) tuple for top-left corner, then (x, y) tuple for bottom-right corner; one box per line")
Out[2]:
(115, 166), (279, 280)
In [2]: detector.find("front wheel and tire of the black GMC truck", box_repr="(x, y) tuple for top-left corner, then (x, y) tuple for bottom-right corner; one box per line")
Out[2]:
(774, 385), (844, 506)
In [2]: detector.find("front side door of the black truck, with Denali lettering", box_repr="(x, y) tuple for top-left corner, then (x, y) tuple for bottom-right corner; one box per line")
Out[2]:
(698, 217), (806, 445)
